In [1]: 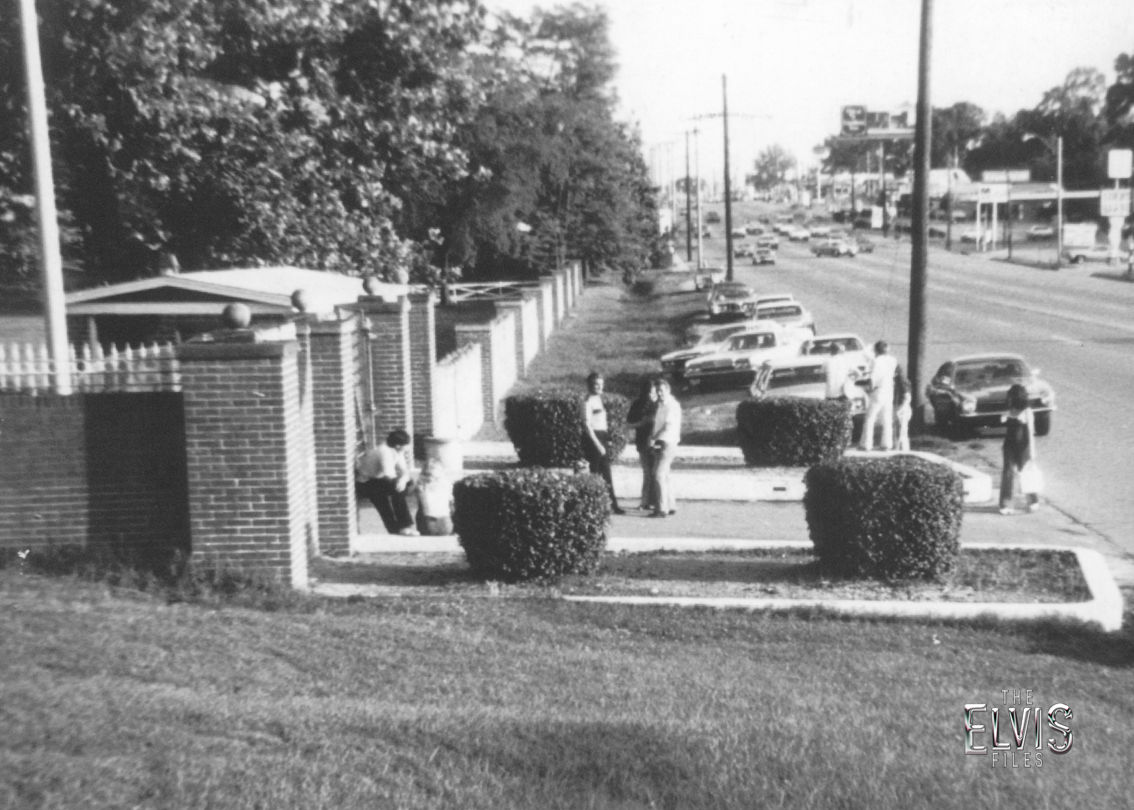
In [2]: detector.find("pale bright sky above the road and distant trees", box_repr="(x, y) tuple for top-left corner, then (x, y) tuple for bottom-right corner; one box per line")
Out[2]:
(485, 0), (1134, 180)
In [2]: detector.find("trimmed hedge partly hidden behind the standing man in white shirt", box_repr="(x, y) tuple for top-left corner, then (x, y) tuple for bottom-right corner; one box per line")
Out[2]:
(503, 386), (631, 467)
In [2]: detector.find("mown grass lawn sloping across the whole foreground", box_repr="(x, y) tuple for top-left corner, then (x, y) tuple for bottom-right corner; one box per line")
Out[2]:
(0, 568), (1134, 810)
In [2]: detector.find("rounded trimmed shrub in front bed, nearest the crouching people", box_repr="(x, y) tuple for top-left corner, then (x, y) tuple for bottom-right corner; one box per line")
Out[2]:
(452, 467), (610, 582)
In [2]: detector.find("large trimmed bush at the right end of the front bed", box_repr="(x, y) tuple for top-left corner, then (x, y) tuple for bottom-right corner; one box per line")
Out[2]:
(803, 455), (964, 580)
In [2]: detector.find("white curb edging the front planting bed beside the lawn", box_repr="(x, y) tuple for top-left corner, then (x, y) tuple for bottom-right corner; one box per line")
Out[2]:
(331, 534), (1123, 633)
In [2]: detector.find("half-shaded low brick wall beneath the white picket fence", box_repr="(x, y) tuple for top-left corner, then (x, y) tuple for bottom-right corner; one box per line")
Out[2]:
(0, 393), (188, 548)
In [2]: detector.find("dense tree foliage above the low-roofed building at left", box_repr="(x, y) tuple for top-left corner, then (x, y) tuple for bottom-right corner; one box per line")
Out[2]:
(0, 0), (653, 292)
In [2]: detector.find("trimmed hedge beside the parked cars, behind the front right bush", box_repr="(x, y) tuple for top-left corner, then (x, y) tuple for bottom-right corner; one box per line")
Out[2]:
(736, 397), (852, 467)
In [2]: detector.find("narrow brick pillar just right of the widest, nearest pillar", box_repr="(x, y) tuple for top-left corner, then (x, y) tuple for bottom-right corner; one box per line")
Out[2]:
(308, 318), (358, 556)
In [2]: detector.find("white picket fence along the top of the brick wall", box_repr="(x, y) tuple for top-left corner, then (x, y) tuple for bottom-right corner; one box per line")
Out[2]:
(0, 343), (181, 394)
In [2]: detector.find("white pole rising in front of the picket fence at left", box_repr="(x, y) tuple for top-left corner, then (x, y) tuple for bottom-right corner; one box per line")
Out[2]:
(19, 0), (71, 395)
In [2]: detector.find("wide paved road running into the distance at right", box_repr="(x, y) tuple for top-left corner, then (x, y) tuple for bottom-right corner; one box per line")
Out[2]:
(706, 221), (1134, 567)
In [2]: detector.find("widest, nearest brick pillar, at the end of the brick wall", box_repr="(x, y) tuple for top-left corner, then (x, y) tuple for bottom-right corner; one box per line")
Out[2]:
(178, 332), (318, 589)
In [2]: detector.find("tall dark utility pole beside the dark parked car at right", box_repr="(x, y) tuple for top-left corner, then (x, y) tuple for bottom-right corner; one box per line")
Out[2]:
(907, 0), (933, 428)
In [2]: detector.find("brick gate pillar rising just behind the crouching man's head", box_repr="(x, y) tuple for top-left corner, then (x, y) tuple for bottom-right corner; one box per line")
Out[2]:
(358, 296), (414, 451)
